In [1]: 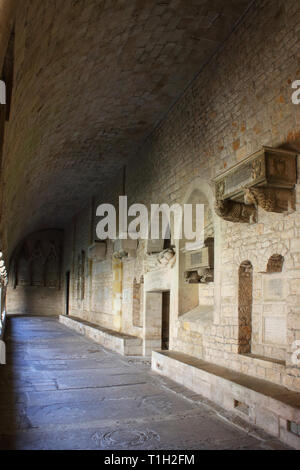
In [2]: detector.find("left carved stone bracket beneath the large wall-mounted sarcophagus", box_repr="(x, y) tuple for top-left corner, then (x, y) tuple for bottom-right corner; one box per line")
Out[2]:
(215, 200), (257, 224)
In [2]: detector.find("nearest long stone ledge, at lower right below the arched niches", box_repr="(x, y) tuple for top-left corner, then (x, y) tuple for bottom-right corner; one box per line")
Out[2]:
(152, 351), (300, 449)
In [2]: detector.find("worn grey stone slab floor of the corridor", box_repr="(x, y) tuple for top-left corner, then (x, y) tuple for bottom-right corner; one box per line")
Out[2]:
(0, 317), (285, 450)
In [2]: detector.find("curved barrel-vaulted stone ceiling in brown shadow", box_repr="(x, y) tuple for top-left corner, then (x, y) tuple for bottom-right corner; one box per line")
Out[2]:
(2, 0), (252, 258)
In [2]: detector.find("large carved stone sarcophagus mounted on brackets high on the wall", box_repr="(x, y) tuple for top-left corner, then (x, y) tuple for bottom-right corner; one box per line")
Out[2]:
(215, 147), (297, 223)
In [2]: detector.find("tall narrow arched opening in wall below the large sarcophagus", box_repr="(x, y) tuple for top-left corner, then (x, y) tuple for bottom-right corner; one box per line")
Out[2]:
(238, 261), (253, 354)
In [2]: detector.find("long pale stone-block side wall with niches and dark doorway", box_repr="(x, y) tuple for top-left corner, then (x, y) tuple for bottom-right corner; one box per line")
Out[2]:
(61, 0), (300, 390)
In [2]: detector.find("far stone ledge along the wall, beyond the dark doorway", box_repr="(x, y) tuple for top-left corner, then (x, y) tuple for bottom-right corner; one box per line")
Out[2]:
(59, 315), (143, 356)
